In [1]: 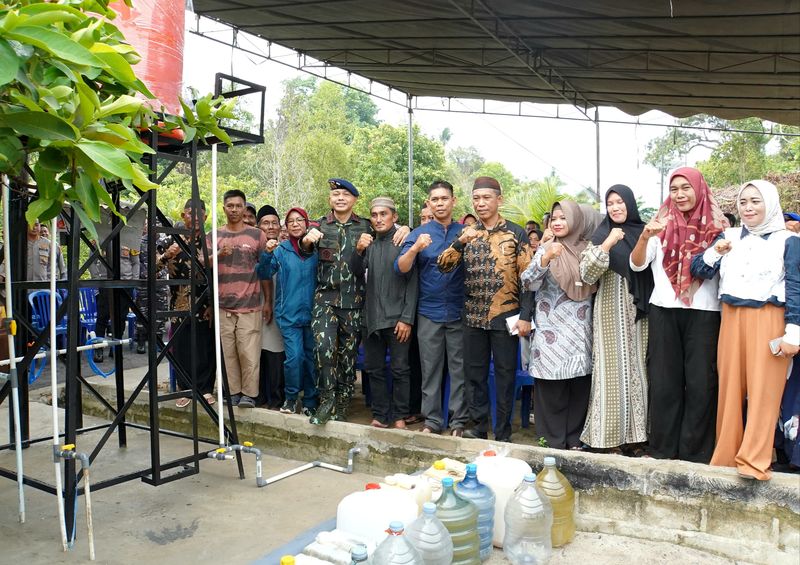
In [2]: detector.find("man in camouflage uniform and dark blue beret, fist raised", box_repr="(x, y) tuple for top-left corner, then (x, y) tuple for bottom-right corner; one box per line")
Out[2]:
(301, 179), (372, 425)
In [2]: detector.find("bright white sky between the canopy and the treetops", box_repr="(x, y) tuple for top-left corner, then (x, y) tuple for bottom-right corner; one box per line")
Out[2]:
(178, 12), (707, 206)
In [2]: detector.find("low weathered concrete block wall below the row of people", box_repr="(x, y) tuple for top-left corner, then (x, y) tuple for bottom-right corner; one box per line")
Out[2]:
(83, 384), (800, 565)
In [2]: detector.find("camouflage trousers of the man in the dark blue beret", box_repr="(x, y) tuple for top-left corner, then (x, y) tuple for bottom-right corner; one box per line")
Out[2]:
(311, 303), (361, 409)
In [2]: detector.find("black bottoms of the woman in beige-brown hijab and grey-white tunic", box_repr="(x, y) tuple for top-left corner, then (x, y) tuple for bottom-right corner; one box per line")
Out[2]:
(533, 375), (592, 449)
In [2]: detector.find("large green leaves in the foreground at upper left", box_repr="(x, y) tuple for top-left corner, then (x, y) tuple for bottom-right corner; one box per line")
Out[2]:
(0, 0), (233, 236)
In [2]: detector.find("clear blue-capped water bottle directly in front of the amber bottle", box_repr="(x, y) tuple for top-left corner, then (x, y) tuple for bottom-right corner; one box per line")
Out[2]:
(503, 473), (553, 565)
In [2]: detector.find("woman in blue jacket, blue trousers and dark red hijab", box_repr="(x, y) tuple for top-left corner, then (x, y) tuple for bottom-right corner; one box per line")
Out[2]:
(256, 208), (317, 416)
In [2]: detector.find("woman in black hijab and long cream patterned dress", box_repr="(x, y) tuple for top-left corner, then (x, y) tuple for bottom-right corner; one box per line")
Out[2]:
(580, 185), (653, 454)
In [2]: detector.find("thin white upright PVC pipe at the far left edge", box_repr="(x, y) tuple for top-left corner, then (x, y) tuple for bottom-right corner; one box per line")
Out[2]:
(2, 175), (25, 524)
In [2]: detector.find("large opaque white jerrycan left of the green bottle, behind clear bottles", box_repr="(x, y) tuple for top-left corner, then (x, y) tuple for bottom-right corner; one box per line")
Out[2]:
(336, 483), (419, 545)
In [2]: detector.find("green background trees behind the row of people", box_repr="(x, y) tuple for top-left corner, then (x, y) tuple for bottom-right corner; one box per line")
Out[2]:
(158, 77), (800, 229)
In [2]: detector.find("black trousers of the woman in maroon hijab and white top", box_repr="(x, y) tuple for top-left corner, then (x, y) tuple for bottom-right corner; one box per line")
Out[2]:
(647, 306), (720, 463)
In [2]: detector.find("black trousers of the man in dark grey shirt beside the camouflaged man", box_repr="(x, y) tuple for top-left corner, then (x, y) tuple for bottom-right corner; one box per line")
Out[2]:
(362, 328), (411, 424)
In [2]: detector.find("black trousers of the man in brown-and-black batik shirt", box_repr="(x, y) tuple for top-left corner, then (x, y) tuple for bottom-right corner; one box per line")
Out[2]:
(464, 325), (519, 441)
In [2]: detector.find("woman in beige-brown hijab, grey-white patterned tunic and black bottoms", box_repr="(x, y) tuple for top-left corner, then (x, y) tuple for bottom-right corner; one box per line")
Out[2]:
(521, 201), (597, 449)
